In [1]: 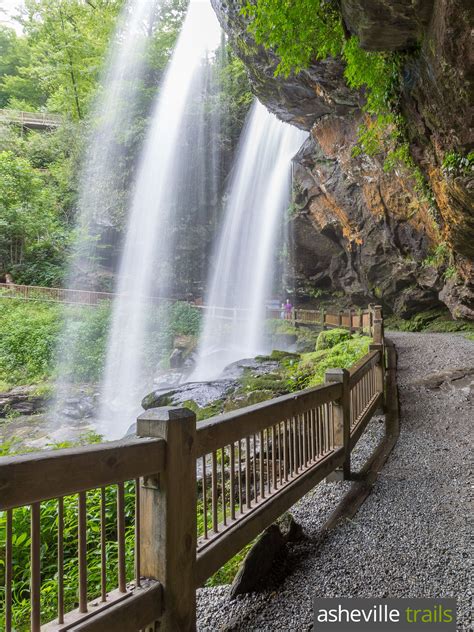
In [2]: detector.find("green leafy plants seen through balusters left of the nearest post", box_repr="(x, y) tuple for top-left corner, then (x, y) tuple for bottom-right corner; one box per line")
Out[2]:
(0, 483), (135, 632)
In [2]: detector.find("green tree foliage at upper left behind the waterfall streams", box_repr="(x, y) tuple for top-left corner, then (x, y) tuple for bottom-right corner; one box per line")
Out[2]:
(0, 0), (252, 291)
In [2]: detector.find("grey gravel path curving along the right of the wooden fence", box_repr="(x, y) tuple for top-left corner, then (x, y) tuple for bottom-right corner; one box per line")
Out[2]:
(198, 333), (474, 632)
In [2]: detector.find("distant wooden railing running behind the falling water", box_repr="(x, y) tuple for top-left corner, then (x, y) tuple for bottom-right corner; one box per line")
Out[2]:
(0, 283), (373, 333)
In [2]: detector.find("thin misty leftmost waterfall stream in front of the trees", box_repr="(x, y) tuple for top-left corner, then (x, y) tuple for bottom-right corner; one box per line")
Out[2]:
(51, 0), (159, 419)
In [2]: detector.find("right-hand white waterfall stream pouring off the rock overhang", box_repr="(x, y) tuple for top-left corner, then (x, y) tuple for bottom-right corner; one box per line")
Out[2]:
(192, 101), (307, 380)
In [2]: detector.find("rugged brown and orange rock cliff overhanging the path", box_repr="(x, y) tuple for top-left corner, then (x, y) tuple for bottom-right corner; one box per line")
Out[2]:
(212, 0), (474, 319)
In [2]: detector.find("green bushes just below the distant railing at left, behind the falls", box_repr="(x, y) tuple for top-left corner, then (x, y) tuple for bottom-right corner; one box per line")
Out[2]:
(0, 299), (201, 390)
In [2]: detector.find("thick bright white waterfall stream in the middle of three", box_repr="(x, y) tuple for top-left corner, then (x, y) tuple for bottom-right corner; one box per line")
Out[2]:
(99, 0), (221, 438)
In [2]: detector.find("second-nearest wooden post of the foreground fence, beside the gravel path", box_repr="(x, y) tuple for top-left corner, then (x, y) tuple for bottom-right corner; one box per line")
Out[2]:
(324, 369), (351, 481)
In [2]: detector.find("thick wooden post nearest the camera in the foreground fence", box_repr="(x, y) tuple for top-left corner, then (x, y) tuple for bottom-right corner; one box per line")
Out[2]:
(137, 407), (197, 632)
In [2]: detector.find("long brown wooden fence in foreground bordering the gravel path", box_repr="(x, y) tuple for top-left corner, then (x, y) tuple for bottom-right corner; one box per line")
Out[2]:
(0, 307), (395, 632)
